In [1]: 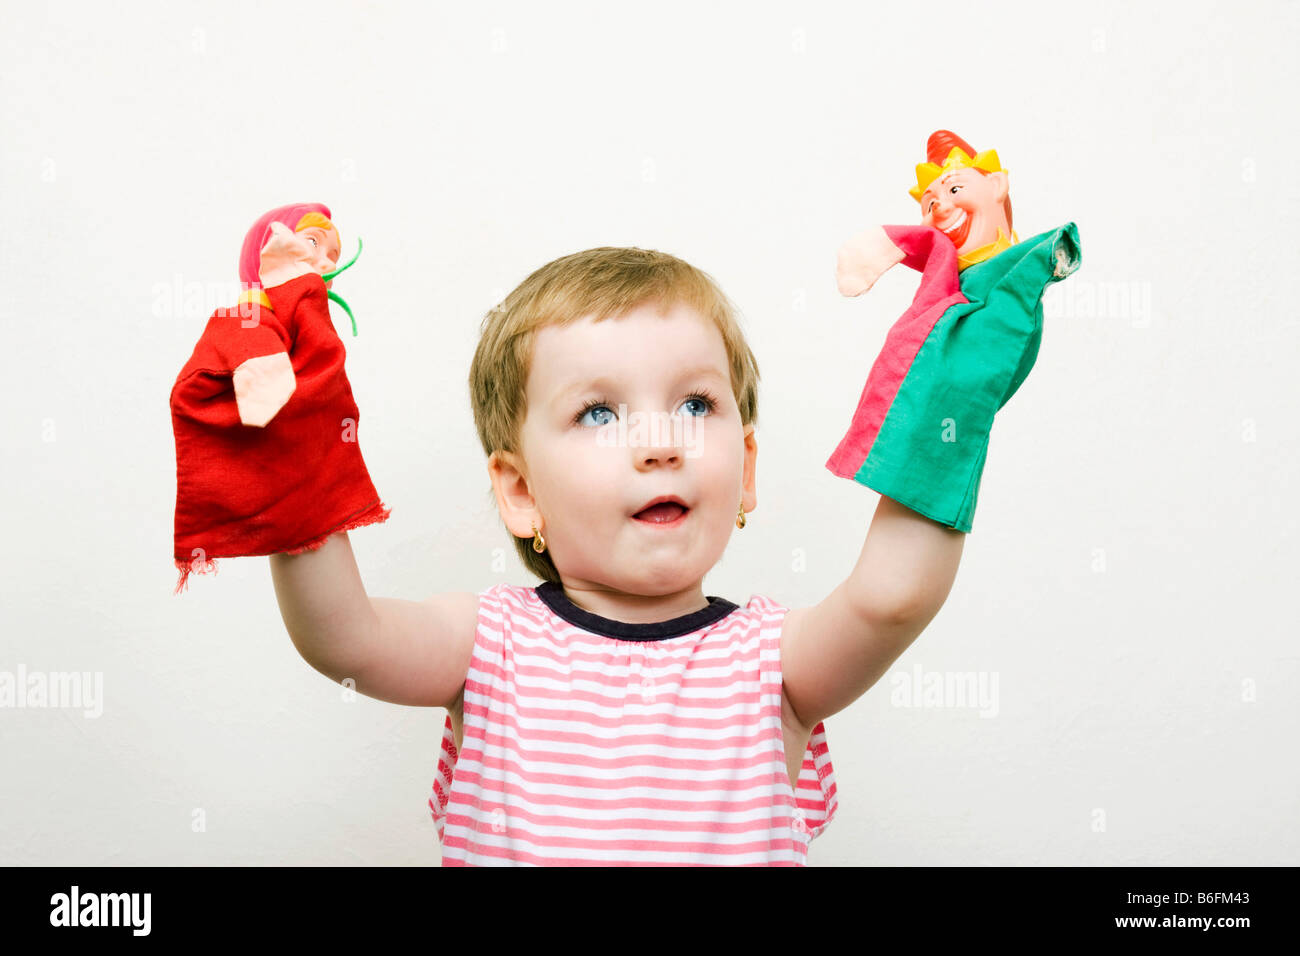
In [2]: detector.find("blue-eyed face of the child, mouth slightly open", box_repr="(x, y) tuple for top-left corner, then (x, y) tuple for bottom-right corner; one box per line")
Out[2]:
(506, 303), (757, 596)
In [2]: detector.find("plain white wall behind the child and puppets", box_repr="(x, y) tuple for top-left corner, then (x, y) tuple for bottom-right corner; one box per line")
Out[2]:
(0, 1), (1300, 865)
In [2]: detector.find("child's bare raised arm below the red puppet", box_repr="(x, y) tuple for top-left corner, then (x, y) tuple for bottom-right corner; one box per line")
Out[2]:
(270, 532), (478, 710)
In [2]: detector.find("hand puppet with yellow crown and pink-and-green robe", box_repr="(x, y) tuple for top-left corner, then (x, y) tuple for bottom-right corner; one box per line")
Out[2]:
(826, 130), (1082, 532)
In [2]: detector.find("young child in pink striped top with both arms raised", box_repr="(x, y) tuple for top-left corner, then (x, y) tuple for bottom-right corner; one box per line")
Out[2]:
(270, 247), (965, 865)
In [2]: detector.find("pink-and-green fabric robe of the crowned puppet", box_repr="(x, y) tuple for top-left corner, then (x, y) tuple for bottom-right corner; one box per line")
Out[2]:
(827, 222), (1082, 532)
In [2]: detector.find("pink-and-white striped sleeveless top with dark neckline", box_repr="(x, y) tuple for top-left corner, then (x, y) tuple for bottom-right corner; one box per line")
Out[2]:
(429, 581), (837, 866)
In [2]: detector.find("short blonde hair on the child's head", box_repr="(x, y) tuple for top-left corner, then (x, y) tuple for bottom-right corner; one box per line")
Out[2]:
(469, 246), (758, 584)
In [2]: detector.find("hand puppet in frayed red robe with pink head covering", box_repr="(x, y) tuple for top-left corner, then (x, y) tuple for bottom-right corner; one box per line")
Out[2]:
(172, 203), (390, 593)
